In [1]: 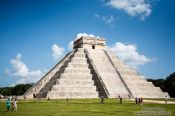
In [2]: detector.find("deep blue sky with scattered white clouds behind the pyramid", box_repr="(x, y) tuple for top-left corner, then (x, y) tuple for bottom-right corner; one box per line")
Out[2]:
(0, 0), (175, 87)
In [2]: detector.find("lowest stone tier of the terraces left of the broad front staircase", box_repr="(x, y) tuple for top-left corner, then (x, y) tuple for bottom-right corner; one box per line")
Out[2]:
(46, 91), (98, 98)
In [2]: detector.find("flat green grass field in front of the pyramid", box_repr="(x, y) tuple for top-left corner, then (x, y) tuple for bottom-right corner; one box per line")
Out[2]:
(0, 99), (175, 116)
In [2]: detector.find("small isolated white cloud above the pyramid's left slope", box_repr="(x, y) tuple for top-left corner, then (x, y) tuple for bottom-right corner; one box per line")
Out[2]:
(52, 44), (64, 61)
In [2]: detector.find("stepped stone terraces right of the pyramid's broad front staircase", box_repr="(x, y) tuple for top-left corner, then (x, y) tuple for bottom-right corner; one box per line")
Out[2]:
(104, 50), (169, 98)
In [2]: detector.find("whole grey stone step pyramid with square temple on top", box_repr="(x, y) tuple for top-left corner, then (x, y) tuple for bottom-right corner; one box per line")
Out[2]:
(23, 36), (168, 99)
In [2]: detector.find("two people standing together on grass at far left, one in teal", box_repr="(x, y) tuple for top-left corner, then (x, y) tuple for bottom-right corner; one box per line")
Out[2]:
(6, 98), (17, 112)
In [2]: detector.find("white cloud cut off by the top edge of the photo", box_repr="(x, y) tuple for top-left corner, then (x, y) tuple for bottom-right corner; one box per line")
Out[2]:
(107, 0), (151, 20)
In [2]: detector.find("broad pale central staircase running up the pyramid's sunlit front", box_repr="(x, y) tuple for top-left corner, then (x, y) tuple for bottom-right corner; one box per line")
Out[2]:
(86, 49), (129, 98)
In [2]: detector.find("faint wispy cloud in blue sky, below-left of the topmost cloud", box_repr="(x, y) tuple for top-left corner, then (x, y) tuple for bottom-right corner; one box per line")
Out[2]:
(94, 14), (115, 27)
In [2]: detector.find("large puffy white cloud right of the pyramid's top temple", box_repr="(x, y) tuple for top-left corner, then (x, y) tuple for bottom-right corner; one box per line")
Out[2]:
(109, 42), (155, 68)
